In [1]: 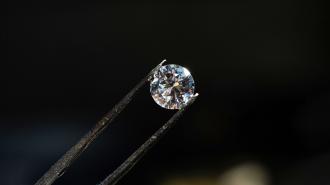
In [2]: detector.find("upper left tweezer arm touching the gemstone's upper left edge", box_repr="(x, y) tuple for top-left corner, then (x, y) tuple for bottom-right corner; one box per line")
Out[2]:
(35, 60), (166, 185)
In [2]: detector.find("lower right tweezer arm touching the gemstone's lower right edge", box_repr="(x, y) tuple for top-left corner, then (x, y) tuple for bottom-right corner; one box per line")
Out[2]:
(99, 94), (198, 185)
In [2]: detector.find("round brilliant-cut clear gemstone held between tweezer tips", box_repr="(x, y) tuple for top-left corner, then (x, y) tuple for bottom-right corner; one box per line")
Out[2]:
(150, 64), (195, 109)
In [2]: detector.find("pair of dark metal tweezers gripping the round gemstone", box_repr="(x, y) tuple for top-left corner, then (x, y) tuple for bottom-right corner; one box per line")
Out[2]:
(35, 60), (198, 185)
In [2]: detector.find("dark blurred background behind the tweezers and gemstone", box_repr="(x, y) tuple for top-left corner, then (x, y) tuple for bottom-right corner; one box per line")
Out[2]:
(0, 0), (330, 185)
